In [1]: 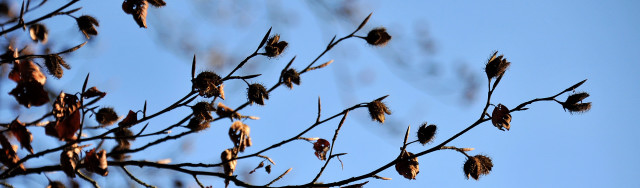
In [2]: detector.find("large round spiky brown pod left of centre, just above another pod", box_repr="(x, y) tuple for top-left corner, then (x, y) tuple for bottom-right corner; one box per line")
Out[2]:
(191, 71), (222, 98)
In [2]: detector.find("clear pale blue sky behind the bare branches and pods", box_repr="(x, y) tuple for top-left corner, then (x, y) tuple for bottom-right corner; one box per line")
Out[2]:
(0, 0), (640, 187)
